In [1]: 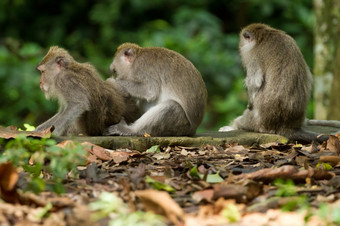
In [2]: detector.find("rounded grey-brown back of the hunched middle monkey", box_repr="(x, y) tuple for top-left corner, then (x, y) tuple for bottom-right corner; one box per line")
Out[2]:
(142, 47), (207, 130)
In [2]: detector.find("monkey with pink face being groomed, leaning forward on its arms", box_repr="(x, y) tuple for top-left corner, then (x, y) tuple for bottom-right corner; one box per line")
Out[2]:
(36, 46), (139, 136)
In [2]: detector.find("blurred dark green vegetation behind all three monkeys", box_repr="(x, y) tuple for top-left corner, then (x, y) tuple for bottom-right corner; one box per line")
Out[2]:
(0, 0), (314, 131)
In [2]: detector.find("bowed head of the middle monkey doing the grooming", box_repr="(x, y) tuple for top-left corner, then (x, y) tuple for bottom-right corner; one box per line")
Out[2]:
(110, 43), (142, 77)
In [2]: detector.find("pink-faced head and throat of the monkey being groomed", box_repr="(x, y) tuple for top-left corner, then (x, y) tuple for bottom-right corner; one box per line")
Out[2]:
(37, 46), (74, 99)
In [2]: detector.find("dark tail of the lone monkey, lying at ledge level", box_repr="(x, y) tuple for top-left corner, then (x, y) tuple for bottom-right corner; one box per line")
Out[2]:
(282, 128), (329, 144)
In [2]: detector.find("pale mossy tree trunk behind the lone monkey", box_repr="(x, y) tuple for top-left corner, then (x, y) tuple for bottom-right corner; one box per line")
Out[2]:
(314, 0), (340, 120)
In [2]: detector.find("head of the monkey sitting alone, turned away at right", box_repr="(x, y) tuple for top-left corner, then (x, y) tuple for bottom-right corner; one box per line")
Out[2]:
(239, 24), (278, 53)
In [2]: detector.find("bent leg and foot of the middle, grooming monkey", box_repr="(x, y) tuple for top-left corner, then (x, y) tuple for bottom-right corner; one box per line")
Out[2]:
(105, 100), (196, 136)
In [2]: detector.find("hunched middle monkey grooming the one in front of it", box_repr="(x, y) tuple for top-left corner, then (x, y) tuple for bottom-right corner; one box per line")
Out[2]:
(106, 43), (207, 136)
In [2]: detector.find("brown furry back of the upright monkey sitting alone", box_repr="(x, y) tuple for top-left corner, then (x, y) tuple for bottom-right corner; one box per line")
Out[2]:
(255, 30), (312, 133)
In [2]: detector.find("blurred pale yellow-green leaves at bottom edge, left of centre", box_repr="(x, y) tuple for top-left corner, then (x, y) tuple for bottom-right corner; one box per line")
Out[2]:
(89, 192), (166, 226)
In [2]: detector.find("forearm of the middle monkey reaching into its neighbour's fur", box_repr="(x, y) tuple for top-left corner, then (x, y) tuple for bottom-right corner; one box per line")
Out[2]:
(116, 79), (160, 102)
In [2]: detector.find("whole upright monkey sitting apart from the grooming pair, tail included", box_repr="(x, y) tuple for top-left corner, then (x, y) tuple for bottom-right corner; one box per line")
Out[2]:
(219, 24), (328, 142)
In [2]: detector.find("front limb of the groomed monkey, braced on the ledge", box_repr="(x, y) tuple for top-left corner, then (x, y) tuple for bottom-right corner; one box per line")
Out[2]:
(35, 104), (84, 136)
